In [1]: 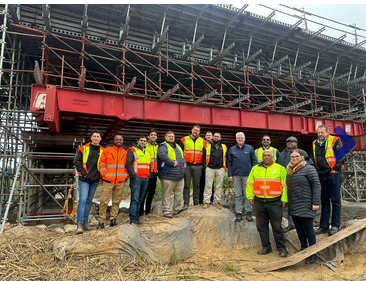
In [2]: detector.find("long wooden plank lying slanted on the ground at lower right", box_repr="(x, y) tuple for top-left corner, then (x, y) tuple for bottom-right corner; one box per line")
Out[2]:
(254, 219), (366, 272)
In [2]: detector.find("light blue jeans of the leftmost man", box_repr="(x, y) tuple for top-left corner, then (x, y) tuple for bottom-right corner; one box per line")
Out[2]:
(77, 181), (99, 223)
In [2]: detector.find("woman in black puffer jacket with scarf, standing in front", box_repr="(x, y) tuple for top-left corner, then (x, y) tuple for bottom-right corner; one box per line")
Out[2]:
(286, 149), (321, 263)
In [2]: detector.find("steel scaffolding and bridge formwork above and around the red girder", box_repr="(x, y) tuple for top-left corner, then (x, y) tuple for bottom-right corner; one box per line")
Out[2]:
(0, 4), (366, 223)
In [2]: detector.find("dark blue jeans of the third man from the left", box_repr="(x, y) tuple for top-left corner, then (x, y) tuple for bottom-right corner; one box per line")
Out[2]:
(130, 177), (149, 223)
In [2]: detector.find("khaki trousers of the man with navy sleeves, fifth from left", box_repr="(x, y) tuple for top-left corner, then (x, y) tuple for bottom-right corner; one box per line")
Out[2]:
(160, 179), (184, 215)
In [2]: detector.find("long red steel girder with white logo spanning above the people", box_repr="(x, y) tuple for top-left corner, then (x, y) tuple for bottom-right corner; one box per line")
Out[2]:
(30, 85), (363, 136)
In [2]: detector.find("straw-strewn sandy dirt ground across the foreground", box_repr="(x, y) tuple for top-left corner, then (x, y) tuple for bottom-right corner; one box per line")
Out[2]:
(0, 199), (366, 281)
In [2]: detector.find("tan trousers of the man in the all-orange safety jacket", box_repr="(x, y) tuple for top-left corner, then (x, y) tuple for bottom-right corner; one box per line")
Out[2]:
(98, 181), (126, 223)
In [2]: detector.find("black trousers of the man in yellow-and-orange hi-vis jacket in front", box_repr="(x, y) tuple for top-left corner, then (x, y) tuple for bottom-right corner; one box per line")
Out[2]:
(254, 197), (286, 251)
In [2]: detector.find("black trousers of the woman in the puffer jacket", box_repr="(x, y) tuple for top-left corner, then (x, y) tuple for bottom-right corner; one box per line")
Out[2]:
(292, 216), (316, 249)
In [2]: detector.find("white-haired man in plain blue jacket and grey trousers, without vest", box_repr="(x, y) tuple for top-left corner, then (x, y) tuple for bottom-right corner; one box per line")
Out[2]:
(227, 132), (257, 222)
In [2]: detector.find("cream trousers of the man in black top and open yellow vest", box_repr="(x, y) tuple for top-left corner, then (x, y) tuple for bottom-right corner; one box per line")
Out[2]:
(203, 167), (225, 204)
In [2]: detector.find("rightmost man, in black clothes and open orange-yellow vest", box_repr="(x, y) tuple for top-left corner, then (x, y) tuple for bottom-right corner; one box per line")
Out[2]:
(311, 125), (344, 235)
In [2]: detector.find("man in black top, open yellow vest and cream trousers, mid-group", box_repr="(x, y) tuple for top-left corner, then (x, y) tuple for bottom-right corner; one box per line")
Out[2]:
(203, 133), (227, 210)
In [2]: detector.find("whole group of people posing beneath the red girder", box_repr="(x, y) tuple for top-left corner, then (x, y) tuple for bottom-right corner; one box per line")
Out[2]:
(74, 125), (343, 263)
